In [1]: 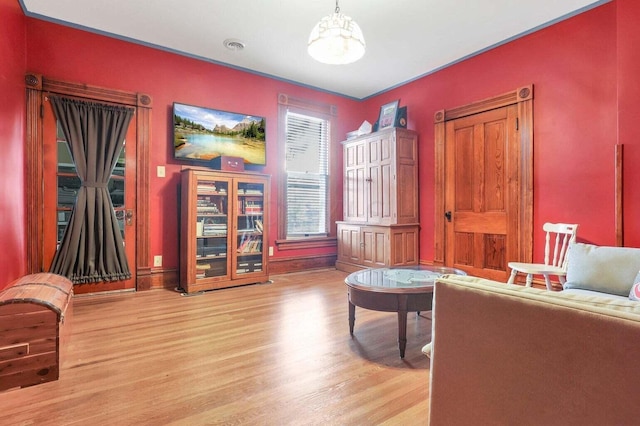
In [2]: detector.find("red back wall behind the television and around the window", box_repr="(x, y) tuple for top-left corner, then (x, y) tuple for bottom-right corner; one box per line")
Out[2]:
(26, 18), (359, 269)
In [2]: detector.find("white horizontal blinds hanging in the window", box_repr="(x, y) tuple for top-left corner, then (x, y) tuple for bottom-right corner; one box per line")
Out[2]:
(285, 111), (329, 238)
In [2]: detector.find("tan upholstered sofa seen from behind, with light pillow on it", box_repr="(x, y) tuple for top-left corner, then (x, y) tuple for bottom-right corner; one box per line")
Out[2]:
(425, 245), (640, 426)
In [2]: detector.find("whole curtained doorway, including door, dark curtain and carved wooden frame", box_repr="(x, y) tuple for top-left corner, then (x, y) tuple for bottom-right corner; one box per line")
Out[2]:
(27, 76), (150, 294)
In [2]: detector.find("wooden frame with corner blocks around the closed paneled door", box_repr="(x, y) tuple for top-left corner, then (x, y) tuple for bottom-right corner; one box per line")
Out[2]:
(433, 84), (533, 265)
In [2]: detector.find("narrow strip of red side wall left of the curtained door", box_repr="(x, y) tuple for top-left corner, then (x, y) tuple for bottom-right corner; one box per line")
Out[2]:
(0, 0), (26, 289)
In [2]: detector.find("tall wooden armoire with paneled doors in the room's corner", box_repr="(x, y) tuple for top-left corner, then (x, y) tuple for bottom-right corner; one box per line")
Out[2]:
(336, 128), (420, 272)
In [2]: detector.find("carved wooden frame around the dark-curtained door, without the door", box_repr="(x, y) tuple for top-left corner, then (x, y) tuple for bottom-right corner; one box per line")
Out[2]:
(25, 73), (152, 290)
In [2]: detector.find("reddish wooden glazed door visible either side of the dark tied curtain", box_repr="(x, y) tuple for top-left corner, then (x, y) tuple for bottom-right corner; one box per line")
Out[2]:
(42, 97), (136, 294)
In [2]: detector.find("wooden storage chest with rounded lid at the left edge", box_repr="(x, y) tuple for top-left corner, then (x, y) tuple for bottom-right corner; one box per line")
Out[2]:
(0, 273), (73, 391)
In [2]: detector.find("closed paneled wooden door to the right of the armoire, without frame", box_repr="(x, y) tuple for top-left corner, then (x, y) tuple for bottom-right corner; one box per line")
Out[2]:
(445, 106), (518, 281)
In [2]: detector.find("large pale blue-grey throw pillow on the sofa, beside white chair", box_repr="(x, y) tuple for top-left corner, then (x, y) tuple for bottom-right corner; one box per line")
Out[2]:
(564, 243), (640, 297)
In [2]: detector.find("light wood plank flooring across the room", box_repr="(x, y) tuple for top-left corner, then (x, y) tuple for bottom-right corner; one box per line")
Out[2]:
(0, 270), (431, 425)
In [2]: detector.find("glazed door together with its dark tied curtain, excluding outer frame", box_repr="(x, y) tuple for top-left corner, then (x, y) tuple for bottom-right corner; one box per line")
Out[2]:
(44, 95), (135, 293)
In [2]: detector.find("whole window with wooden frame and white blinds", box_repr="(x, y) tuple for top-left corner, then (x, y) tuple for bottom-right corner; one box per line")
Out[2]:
(276, 94), (340, 250)
